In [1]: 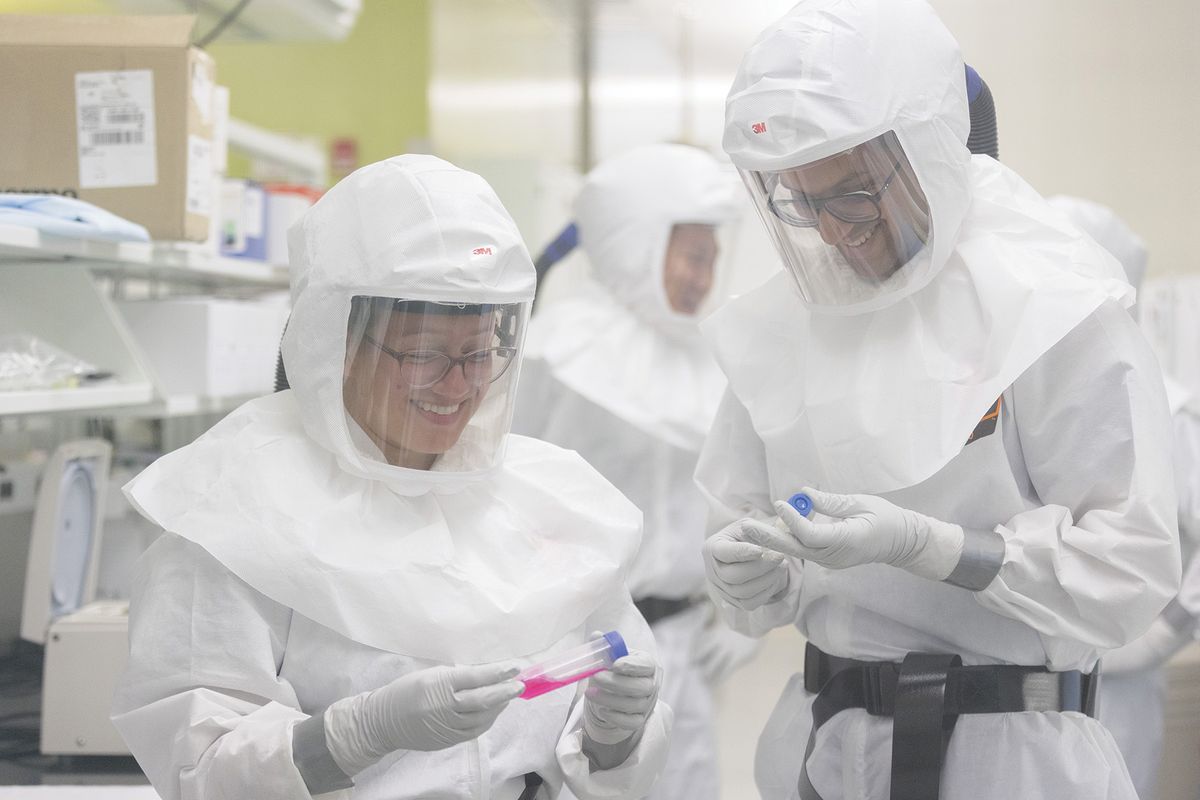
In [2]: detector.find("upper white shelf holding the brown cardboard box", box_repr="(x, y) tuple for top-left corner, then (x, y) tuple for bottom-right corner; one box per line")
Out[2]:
(0, 224), (288, 288)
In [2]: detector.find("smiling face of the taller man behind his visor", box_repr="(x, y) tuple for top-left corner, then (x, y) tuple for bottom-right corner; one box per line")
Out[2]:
(779, 140), (929, 283)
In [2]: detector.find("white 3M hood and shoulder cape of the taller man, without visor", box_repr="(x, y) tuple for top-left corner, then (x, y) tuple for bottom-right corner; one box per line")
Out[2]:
(704, 0), (1133, 493)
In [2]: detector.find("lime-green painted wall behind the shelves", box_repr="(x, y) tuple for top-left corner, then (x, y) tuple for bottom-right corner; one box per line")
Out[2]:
(0, 0), (433, 185)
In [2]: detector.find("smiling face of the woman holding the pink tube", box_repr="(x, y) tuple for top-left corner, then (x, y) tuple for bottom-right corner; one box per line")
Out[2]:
(342, 311), (496, 469)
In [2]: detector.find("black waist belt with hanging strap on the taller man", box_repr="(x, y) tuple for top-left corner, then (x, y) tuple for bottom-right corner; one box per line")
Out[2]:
(799, 643), (1099, 800)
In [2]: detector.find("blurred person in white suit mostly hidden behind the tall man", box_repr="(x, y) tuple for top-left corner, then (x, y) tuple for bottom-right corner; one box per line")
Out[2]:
(1049, 194), (1200, 799)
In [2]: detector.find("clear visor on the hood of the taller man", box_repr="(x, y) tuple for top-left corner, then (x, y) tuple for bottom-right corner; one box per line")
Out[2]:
(739, 132), (932, 306)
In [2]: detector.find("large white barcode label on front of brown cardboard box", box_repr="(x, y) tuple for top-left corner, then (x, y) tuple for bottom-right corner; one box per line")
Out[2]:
(76, 70), (158, 188)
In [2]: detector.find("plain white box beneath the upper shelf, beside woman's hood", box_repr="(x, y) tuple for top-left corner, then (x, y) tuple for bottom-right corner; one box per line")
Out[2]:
(118, 297), (288, 397)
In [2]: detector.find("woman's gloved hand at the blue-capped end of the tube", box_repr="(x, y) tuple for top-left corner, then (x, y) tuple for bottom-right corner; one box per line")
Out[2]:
(583, 633), (662, 769)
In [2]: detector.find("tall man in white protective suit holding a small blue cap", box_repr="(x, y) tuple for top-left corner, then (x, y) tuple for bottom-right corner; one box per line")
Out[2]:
(697, 0), (1180, 800)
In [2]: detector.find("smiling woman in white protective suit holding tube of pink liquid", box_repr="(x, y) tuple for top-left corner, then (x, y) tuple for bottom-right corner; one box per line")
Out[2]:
(113, 156), (671, 800)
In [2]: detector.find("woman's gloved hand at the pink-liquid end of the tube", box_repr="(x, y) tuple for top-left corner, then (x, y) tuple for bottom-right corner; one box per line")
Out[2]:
(325, 664), (524, 775)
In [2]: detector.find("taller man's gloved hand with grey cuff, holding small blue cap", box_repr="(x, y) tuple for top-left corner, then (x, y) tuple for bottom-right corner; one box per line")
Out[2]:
(746, 488), (965, 581)
